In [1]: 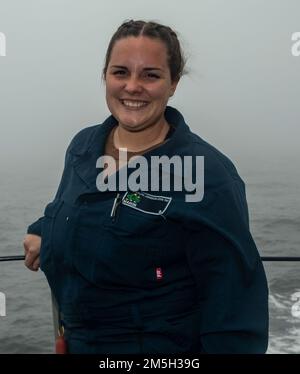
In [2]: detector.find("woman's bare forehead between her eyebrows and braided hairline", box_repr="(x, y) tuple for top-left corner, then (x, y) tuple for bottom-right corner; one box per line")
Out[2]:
(109, 36), (168, 68)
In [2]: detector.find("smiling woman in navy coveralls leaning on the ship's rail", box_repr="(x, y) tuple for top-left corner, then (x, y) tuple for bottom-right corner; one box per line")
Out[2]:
(24, 21), (268, 354)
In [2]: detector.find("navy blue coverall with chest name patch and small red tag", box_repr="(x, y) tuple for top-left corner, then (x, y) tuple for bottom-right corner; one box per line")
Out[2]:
(28, 107), (268, 354)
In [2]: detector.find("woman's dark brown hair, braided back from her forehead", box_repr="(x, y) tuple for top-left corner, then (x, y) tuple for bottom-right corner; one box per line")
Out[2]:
(103, 20), (185, 82)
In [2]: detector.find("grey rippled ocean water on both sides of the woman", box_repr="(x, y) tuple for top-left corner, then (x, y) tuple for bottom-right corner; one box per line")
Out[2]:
(0, 163), (300, 354)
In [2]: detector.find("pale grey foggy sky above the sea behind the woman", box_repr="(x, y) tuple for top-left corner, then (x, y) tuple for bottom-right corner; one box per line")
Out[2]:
(0, 0), (300, 174)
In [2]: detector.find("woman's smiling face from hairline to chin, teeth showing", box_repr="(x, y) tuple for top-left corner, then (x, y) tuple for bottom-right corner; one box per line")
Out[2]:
(105, 36), (178, 131)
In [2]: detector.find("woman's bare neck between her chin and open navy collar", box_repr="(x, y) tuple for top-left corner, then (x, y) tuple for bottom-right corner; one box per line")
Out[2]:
(114, 120), (170, 152)
